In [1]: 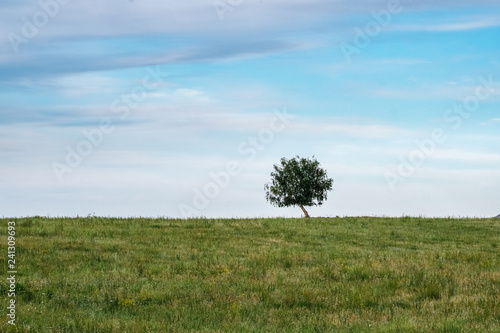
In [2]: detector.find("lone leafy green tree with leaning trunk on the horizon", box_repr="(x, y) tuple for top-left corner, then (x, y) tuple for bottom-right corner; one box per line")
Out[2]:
(264, 156), (333, 218)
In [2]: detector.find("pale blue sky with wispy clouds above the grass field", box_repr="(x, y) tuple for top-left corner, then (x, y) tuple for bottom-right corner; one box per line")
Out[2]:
(0, 0), (500, 218)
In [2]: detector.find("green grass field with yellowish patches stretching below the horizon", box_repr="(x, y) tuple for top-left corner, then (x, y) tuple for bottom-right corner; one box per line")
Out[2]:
(0, 217), (500, 333)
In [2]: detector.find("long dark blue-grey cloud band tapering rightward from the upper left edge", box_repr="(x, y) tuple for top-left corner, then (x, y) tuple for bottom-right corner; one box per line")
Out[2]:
(0, 40), (307, 82)
